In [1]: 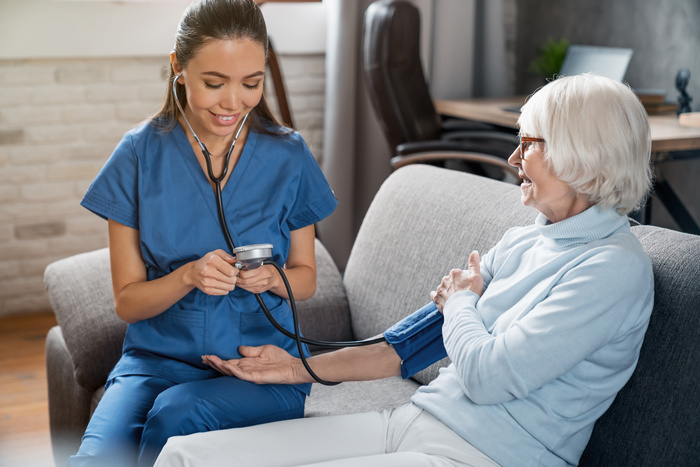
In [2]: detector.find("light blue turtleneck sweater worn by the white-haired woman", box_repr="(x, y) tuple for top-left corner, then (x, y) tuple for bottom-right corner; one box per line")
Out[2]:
(411, 206), (654, 466)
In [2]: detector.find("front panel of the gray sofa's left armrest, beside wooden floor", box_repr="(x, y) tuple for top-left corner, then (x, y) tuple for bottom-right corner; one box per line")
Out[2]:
(46, 326), (92, 465)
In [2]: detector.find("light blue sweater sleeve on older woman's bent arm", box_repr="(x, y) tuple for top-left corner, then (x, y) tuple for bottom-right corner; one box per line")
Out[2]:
(443, 245), (653, 404)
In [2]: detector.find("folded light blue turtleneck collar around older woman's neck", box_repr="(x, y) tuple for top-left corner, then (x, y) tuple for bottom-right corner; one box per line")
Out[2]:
(535, 205), (629, 248)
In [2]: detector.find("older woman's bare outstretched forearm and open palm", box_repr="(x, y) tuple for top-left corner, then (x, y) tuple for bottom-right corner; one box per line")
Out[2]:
(202, 342), (401, 384)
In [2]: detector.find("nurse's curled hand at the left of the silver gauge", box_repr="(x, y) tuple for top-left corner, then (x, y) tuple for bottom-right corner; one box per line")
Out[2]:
(185, 250), (238, 295)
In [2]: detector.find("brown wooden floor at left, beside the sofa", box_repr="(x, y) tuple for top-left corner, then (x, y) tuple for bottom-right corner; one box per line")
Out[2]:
(0, 312), (56, 467)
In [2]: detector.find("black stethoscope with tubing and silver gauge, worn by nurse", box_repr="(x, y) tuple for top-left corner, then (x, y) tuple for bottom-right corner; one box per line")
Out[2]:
(173, 75), (386, 386)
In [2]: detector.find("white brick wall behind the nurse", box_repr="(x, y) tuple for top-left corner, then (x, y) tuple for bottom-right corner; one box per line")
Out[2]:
(0, 55), (325, 316)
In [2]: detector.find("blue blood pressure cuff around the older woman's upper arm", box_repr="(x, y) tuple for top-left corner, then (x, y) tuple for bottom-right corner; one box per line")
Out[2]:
(384, 302), (447, 379)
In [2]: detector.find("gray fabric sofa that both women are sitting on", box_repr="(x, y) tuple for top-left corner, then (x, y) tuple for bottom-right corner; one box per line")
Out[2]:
(45, 165), (700, 466)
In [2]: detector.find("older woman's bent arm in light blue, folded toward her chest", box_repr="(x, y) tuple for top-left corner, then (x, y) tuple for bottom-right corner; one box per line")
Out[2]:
(443, 238), (653, 404)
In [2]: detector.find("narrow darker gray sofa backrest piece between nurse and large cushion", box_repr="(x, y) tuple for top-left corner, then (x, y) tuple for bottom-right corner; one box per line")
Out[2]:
(297, 240), (353, 350)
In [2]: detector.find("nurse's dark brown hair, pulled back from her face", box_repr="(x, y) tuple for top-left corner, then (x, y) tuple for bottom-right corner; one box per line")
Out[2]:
(153, 0), (286, 134)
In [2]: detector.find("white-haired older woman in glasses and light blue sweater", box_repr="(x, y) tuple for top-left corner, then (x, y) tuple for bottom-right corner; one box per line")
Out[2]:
(158, 75), (654, 466)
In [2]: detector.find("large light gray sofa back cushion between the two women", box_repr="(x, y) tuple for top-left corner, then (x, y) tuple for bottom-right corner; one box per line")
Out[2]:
(344, 165), (537, 384)
